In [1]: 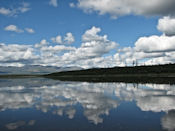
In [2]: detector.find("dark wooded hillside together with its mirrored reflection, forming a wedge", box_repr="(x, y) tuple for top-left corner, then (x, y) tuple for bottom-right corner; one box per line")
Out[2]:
(44, 64), (175, 84)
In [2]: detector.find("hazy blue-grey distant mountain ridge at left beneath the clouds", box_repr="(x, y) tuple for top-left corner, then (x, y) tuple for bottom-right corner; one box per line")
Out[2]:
(0, 65), (83, 75)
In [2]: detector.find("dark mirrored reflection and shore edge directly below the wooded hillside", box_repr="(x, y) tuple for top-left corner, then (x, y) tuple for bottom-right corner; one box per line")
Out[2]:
(45, 74), (175, 84)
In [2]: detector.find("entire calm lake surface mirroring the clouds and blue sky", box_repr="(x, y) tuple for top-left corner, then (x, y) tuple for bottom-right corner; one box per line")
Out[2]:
(0, 78), (175, 131)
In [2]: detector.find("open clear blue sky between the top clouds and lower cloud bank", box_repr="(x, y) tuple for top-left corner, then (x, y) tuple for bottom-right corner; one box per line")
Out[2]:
(0, 0), (159, 46)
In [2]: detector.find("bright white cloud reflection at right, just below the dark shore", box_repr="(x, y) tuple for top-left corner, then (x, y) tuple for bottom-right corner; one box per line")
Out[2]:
(115, 84), (175, 112)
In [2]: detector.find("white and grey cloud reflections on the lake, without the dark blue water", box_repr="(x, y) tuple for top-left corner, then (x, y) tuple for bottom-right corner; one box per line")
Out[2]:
(0, 78), (175, 130)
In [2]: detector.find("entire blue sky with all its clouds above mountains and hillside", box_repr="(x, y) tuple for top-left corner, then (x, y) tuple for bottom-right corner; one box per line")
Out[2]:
(0, 0), (175, 68)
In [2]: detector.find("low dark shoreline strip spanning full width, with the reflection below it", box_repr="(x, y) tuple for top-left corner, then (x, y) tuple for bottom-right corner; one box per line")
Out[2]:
(0, 74), (175, 84)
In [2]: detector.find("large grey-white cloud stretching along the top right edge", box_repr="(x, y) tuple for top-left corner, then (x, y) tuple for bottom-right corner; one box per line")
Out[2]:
(77, 0), (175, 18)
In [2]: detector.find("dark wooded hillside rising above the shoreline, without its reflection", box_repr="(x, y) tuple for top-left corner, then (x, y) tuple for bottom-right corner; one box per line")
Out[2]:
(46, 64), (175, 75)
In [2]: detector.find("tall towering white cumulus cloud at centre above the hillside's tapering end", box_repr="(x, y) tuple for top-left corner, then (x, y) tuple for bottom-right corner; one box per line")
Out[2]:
(63, 27), (117, 61)
